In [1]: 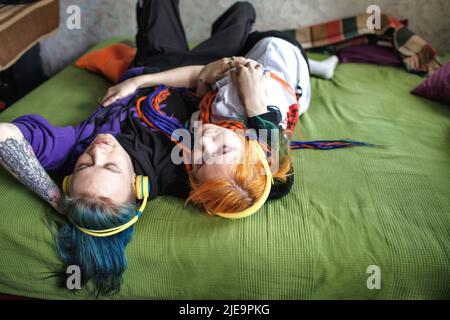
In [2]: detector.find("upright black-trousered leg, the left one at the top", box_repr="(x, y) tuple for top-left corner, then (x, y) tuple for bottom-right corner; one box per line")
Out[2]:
(133, 0), (189, 70)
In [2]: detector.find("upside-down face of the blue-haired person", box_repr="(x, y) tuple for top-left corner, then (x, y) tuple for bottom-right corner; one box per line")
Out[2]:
(70, 134), (135, 205)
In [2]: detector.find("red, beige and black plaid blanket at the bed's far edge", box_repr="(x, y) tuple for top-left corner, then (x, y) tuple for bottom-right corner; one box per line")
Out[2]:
(285, 14), (441, 74)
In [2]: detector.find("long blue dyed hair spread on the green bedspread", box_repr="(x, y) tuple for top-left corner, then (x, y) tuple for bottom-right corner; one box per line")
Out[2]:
(56, 196), (136, 294)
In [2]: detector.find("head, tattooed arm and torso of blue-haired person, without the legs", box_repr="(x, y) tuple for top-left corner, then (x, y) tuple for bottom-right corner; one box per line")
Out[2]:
(0, 90), (196, 294)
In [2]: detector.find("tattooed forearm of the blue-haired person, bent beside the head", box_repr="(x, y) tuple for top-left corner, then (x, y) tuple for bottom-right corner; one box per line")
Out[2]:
(0, 123), (62, 213)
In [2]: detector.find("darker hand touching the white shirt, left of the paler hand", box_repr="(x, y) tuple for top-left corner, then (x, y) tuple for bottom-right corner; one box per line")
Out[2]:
(197, 57), (248, 97)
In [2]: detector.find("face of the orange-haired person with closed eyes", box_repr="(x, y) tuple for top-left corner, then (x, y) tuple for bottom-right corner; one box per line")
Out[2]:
(193, 124), (245, 182)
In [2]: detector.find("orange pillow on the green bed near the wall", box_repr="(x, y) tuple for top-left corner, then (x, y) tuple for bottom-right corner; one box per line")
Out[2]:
(75, 43), (136, 83)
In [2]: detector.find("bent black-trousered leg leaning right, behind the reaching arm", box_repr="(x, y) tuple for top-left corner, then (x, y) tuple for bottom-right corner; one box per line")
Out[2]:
(189, 2), (256, 64)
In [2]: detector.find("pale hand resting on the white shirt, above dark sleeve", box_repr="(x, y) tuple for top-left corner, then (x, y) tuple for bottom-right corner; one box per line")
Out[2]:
(230, 60), (268, 117)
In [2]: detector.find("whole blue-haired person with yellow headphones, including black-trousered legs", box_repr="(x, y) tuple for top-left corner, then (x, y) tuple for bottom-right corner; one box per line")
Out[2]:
(0, 0), (268, 294)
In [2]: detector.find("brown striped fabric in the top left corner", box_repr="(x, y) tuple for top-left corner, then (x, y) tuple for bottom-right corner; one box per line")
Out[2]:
(0, 0), (59, 71)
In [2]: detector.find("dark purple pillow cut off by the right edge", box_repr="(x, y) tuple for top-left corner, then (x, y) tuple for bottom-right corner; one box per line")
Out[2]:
(411, 62), (450, 105)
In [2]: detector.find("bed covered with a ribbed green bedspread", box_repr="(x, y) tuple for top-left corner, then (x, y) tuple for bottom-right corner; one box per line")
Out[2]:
(0, 38), (450, 299)
